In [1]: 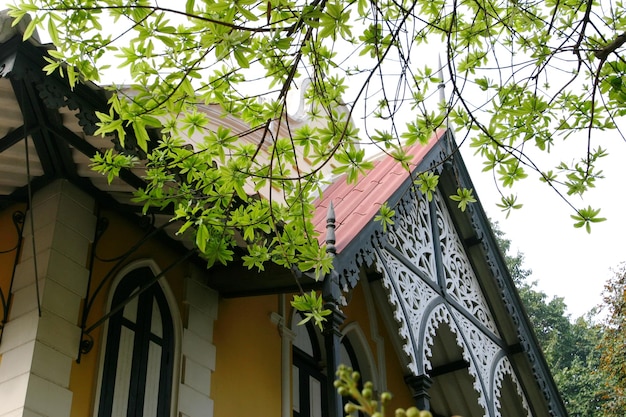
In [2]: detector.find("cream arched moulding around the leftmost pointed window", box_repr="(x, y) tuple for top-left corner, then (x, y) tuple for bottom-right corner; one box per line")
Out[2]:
(93, 259), (182, 417)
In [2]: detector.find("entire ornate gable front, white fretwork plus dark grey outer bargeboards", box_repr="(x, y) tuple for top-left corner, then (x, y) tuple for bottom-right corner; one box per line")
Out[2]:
(335, 132), (565, 416)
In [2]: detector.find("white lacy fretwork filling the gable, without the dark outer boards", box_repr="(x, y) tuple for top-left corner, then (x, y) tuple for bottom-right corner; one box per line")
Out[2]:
(374, 189), (532, 417)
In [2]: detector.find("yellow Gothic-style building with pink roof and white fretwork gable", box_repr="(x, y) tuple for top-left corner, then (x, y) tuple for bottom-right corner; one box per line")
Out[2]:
(0, 15), (566, 417)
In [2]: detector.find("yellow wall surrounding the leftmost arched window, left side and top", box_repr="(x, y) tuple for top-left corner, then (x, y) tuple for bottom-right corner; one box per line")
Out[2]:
(70, 211), (189, 417)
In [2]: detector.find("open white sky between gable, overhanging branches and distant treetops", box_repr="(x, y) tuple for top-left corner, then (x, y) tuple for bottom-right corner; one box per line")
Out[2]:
(7, 0), (626, 319)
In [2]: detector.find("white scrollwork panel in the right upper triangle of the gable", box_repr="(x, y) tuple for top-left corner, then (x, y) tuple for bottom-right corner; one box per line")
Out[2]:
(434, 193), (498, 335)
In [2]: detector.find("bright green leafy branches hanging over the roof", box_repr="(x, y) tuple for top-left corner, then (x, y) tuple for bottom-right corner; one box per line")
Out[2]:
(10, 0), (626, 276)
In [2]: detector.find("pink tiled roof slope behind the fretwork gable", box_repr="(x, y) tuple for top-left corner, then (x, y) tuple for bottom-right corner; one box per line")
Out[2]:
(313, 130), (445, 253)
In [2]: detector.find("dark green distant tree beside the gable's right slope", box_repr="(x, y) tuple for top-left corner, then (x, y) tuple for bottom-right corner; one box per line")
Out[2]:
(493, 223), (604, 417)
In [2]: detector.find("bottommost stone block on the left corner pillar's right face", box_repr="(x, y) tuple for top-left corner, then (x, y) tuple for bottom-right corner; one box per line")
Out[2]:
(26, 374), (72, 417)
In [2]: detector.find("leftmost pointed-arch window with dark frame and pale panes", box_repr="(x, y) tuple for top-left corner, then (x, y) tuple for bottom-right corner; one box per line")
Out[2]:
(98, 267), (175, 417)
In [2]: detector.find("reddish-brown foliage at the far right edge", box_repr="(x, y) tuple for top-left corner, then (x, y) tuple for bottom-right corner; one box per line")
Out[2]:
(599, 264), (626, 417)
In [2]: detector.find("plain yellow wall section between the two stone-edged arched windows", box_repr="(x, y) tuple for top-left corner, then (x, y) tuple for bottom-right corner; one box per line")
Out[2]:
(211, 296), (281, 417)
